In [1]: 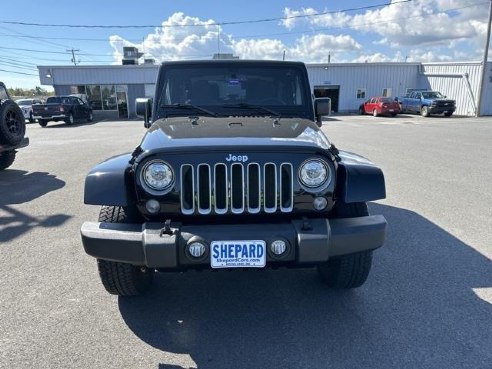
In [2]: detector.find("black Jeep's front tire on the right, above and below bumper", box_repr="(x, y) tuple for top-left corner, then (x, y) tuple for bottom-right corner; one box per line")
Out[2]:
(318, 202), (372, 289)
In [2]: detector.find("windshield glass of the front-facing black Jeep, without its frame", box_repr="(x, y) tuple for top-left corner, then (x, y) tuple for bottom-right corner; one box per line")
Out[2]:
(159, 65), (309, 115)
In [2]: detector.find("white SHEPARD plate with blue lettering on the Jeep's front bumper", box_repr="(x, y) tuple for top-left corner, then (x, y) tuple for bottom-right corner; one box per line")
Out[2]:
(210, 240), (266, 268)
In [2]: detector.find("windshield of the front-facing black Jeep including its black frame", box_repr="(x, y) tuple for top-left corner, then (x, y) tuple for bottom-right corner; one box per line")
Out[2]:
(153, 60), (314, 121)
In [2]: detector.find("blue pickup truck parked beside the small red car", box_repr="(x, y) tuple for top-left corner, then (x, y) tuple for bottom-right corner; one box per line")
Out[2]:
(400, 91), (456, 117)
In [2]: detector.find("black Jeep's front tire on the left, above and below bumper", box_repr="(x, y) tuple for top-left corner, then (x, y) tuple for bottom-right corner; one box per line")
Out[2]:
(97, 206), (154, 296)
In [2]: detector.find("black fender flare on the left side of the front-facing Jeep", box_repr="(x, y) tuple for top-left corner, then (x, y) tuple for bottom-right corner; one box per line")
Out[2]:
(84, 153), (133, 206)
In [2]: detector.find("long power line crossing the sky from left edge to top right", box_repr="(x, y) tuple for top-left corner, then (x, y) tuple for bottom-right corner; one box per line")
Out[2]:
(0, 0), (413, 28)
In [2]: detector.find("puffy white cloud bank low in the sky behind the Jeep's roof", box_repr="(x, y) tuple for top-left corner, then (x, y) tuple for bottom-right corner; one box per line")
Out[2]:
(110, 13), (362, 64)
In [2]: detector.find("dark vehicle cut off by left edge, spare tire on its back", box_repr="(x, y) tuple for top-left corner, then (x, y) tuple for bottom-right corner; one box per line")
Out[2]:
(0, 82), (29, 170)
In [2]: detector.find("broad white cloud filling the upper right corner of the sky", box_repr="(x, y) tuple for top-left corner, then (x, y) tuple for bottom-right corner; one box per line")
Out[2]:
(284, 0), (488, 60)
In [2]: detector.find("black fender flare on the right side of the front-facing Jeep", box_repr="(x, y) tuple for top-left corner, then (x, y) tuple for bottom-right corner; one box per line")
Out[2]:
(336, 151), (386, 203)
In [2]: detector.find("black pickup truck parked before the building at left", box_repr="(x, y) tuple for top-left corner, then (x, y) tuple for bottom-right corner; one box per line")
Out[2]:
(32, 96), (93, 127)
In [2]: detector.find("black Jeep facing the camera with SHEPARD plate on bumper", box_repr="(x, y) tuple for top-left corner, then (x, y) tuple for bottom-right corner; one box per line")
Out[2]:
(81, 60), (386, 295)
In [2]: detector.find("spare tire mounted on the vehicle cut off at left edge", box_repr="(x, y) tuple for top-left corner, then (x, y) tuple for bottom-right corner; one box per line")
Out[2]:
(0, 100), (26, 145)
